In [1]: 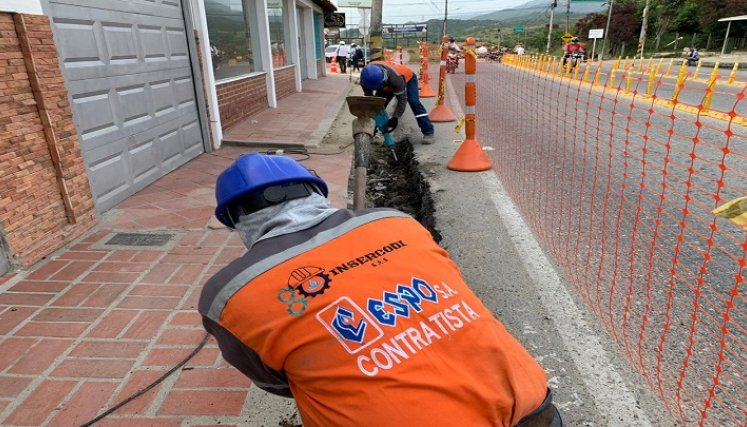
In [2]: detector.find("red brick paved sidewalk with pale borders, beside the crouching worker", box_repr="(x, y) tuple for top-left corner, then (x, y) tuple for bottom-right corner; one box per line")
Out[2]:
(0, 82), (351, 426)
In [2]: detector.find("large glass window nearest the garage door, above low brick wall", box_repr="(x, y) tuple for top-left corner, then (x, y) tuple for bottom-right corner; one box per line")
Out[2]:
(205, 0), (259, 80)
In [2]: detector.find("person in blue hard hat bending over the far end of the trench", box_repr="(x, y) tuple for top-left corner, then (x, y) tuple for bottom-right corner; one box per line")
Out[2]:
(360, 61), (435, 144)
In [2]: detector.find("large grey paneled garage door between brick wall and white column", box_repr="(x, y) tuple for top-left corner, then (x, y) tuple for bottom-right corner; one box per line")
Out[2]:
(48, 0), (204, 212)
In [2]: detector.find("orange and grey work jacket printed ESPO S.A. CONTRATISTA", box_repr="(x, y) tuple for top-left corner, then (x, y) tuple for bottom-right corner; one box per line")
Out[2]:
(201, 210), (547, 427)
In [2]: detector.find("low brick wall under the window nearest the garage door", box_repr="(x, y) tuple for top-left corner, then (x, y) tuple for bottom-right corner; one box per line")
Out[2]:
(215, 74), (267, 130)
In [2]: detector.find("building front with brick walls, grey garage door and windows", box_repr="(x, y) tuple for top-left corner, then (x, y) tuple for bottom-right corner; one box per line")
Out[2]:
(0, 0), (334, 274)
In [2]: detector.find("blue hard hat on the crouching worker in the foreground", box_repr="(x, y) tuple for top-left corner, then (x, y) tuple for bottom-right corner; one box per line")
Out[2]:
(215, 153), (328, 228)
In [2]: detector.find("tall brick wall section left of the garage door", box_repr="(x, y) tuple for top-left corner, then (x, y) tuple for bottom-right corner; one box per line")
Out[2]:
(0, 13), (96, 267)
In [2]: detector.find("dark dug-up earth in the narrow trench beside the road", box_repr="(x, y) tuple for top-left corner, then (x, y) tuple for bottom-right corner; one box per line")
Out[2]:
(366, 140), (441, 242)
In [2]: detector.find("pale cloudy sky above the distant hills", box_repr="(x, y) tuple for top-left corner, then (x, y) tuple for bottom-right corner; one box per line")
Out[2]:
(333, 0), (536, 25)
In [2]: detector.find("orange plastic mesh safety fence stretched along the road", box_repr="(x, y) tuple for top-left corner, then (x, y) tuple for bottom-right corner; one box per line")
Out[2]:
(449, 62), (747, 426)
